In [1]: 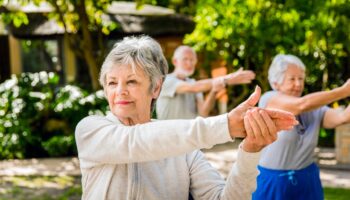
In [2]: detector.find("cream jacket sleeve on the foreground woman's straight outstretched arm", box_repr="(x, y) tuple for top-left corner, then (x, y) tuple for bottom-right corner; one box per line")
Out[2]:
(75, 114), (232, 168)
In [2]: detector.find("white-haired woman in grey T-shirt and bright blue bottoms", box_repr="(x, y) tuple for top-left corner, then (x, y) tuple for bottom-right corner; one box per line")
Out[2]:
(253, 55), (350, 200)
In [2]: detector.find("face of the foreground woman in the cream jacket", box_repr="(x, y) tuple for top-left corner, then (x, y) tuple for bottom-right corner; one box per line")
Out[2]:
(104, 65), (160, 125)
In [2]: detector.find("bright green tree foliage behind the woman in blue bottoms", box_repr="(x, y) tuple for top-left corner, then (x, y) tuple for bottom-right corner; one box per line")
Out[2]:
(185, 0), (350, 108)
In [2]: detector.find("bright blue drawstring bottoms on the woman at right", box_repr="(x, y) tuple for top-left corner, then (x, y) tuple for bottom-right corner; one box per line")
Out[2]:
(252, 163), (324, 200)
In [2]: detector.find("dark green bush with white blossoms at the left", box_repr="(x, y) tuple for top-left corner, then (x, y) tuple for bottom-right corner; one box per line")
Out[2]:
(0, 72), (108, 159)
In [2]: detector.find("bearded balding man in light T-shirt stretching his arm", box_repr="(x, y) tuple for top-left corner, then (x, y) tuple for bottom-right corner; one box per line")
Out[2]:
(156, 46), (255, 119)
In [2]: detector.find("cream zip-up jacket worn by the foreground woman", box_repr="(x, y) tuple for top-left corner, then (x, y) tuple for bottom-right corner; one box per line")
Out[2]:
(75, 114), (260, 200)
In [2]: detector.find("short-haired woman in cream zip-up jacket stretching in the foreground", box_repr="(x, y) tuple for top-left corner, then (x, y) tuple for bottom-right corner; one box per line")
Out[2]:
(75, 36), (296, 200)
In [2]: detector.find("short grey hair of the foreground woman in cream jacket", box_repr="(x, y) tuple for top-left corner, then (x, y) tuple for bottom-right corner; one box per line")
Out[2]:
(99, 35), (168, 91)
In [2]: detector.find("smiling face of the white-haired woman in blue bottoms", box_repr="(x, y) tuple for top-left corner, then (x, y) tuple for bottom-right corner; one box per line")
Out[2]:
(275, 64), (305, 97)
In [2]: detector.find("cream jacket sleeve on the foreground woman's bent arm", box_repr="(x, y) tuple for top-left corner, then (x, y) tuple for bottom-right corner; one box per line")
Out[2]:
(190, 148), (260, 200)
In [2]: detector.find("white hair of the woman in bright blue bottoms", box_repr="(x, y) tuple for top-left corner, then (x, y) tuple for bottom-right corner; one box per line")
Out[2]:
(268, 54), (305, 90)
